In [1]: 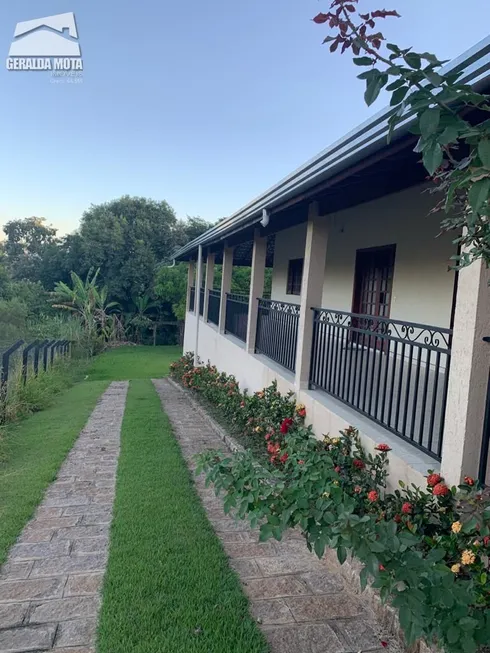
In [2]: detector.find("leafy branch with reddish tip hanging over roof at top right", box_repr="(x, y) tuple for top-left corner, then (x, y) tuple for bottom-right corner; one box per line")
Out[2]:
(313, 0), (490, 267)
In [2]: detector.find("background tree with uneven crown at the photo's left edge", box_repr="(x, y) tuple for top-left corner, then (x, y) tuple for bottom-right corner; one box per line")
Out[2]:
(3, 217), (56, 281)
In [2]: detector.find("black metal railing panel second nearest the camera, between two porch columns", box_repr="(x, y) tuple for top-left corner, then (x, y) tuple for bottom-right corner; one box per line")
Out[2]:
(255, 298), (299, 372)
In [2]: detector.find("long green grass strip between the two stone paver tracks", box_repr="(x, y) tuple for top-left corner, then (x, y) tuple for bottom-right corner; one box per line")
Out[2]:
(97, 380), (268, 653)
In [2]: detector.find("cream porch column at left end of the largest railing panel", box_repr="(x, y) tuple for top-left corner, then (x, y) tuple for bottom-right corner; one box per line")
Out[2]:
(295, 202), (328, 392)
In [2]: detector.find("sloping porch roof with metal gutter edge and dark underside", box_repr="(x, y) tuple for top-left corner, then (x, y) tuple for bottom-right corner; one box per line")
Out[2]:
(173, 36), (490, 264)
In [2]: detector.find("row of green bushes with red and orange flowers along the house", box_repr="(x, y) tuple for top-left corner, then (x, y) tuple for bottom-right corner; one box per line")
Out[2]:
(171, 354), (490, 653)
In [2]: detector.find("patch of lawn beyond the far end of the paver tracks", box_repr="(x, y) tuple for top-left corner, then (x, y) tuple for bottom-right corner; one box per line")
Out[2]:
(89, 346), (182, 381)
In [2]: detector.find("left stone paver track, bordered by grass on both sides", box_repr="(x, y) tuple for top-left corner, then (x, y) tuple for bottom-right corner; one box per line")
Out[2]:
(0, 382), (128, 653)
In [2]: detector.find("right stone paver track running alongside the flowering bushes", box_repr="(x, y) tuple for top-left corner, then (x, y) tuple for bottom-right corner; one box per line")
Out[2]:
(154, 380), (384, 653)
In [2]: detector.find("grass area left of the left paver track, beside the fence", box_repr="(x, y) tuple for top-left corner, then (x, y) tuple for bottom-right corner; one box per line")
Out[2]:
(0, 381), (107, 564)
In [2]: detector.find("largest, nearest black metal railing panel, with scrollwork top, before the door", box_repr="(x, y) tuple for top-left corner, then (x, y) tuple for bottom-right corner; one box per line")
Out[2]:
(310, 308), (452, 460)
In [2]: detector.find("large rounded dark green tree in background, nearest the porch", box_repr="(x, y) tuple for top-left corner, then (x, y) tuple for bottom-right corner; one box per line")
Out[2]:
(79, 195), (177, 309)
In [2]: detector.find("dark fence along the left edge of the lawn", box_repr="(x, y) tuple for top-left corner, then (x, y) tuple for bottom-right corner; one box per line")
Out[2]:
(0, 340), (71, 416)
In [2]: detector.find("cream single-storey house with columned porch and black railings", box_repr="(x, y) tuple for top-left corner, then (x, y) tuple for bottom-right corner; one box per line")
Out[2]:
(175, 38), (490, 484)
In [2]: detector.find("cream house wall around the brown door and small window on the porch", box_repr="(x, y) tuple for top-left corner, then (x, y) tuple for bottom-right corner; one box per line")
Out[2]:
(272, 187), (455, 327)
